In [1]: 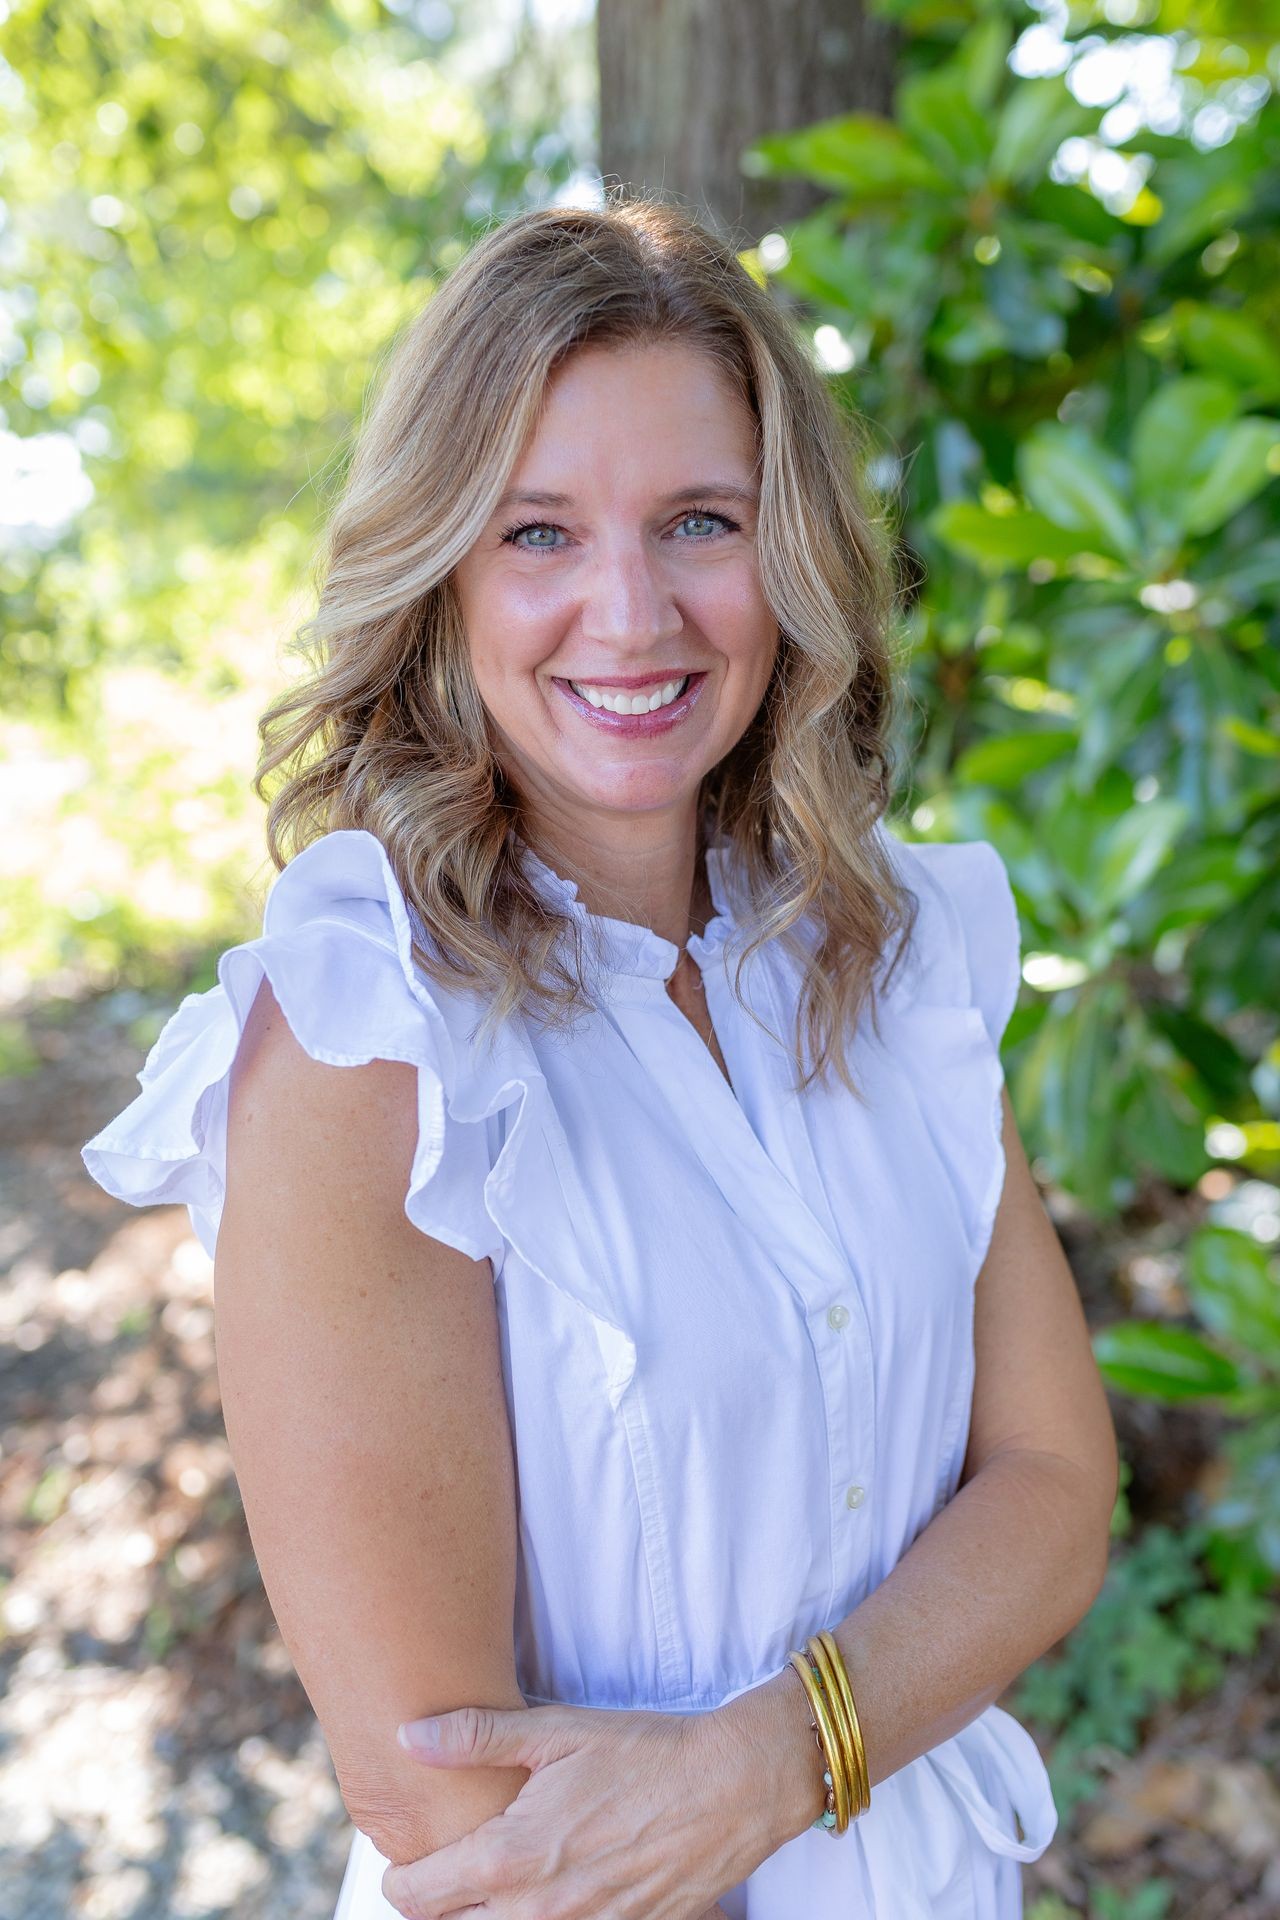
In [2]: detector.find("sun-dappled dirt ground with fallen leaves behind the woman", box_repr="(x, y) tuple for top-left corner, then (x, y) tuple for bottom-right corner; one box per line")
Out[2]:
(0, 991), (1280, 1920)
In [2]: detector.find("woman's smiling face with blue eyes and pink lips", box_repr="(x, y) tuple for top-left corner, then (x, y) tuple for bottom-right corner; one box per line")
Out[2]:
(453, 342), (779, 831)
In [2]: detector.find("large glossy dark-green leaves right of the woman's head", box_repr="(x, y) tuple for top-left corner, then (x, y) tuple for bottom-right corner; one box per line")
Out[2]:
(752, 0), (1280, 1219)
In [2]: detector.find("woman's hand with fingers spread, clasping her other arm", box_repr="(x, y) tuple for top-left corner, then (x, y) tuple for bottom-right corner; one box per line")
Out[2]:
(382, 1705), (762, 1920)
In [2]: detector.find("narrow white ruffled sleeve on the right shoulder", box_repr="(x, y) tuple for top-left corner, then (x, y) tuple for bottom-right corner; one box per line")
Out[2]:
(883, 831), (1021, 1273)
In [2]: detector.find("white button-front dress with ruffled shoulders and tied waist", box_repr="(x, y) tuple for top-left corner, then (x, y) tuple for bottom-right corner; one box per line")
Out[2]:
(83, 828), (1057, 1920)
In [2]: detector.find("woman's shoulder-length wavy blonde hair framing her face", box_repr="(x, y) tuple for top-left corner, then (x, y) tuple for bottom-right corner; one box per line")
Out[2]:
(253, 190), (917, 1098)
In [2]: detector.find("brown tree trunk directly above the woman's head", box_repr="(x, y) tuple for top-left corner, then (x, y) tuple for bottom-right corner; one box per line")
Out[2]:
(597, 0), (894, 246)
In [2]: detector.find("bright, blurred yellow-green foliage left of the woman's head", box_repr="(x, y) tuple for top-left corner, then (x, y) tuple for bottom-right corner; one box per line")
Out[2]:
(0, 0), (593, 998)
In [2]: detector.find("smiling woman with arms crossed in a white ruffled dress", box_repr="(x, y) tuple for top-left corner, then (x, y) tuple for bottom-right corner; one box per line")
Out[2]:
(84, 200), (1117, 1920)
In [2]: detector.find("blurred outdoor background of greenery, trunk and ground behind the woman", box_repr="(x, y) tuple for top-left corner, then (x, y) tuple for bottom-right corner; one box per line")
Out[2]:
(0, 0), (1280, 1920)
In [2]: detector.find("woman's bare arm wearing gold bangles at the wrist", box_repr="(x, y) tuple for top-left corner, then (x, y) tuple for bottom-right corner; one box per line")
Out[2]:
(708, 1092), (1119, 1851)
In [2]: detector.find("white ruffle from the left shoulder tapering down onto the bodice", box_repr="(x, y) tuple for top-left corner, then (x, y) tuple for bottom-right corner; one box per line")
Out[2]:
(81, 828), (633, 1351)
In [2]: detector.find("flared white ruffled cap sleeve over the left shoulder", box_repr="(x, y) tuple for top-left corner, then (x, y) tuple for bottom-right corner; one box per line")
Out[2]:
(81, 829), (503, 1273)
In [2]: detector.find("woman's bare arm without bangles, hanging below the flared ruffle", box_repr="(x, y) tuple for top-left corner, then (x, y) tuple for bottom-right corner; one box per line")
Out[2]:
(215, 983), (528, 1864)
